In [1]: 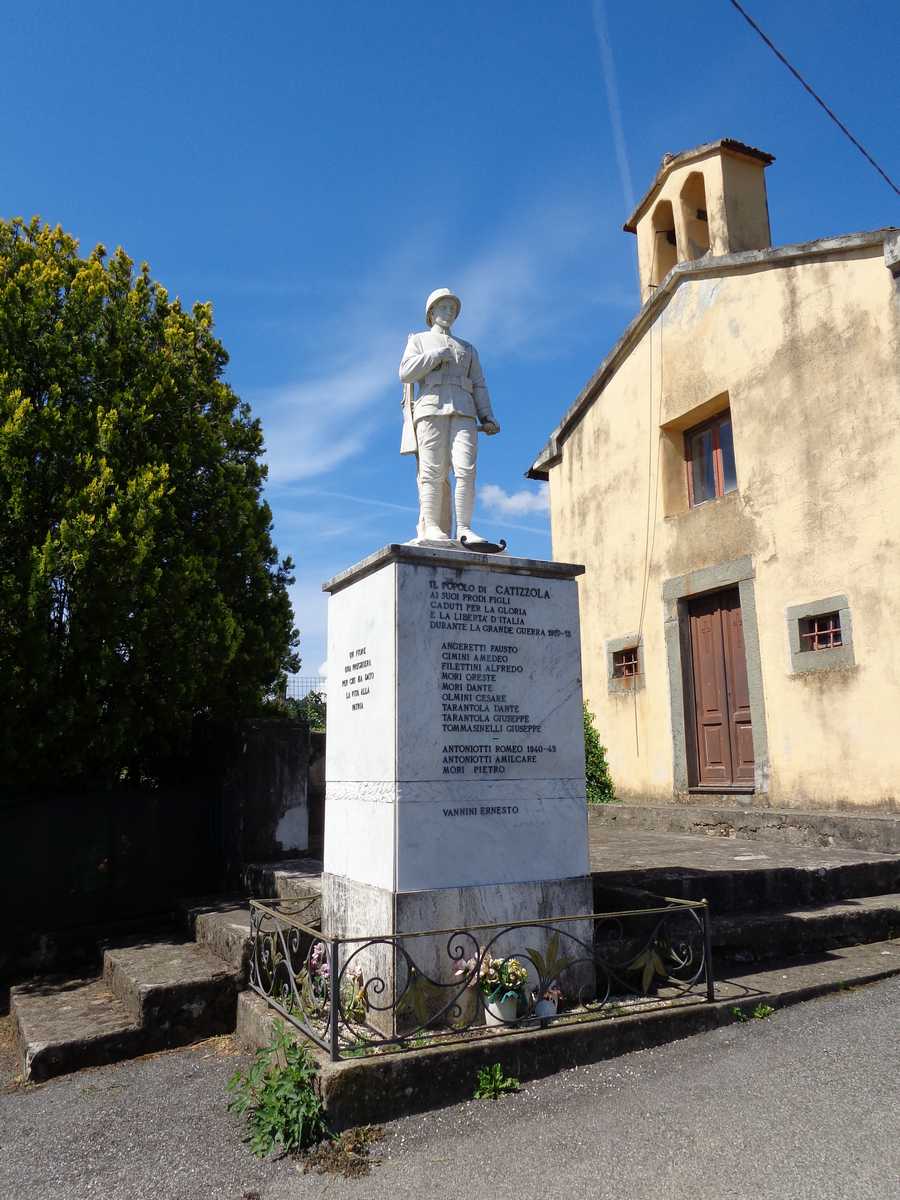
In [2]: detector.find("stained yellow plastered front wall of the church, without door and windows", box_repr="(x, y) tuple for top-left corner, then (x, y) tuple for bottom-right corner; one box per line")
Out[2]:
(550, 247), (900, 808)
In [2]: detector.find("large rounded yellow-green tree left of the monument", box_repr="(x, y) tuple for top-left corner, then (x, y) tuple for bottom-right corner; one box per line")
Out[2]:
(0, 218), (299, 786)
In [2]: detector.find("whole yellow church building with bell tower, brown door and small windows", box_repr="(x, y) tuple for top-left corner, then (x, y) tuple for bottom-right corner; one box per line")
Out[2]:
(528, 139), (900, 810)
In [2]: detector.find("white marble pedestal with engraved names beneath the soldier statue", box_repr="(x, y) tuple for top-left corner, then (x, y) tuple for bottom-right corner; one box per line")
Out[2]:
(323, 545), (592, 1032)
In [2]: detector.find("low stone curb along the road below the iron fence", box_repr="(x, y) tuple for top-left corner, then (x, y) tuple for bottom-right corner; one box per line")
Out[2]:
(235, 942), (900, 1129)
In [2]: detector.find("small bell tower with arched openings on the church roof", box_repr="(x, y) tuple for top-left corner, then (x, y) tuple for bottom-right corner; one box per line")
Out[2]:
(624, 138), (775, 302)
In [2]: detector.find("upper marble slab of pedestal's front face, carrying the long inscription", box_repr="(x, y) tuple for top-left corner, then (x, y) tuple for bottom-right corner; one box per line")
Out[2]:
(398, 569), (584, 787)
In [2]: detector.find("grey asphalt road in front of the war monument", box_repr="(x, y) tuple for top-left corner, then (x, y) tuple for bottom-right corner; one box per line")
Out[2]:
(0, 978), (900, 1200)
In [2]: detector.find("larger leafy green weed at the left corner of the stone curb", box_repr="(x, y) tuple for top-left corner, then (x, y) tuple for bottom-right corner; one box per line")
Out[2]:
(228, 1021), (329, 1158)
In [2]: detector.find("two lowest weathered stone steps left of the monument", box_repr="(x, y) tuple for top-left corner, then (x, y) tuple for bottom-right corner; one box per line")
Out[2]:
(10, 940), (240, 1080)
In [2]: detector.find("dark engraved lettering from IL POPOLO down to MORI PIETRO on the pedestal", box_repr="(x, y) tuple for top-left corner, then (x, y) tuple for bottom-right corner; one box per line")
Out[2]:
(428, 578), (574, 778)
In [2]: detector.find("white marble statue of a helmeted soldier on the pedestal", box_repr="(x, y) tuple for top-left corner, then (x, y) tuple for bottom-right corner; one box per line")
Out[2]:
(400, 288), (500, 550)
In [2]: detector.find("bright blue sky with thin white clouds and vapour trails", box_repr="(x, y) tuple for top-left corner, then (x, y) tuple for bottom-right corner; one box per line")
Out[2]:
(0, 0), (900, 674)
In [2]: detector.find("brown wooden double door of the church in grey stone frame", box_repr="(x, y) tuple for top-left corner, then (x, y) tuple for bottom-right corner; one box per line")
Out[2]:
(689, 588), (754, 787)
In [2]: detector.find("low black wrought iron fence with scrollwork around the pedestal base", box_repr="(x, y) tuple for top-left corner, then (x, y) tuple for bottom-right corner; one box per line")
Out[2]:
(250, 896), (714, 1061)
